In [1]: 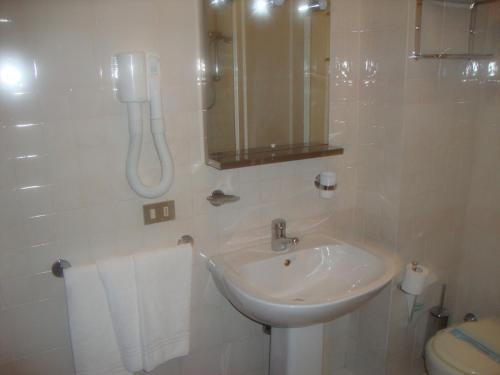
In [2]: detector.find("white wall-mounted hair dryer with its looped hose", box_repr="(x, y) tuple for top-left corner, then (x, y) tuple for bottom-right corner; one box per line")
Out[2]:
(113, 52), (174, 198)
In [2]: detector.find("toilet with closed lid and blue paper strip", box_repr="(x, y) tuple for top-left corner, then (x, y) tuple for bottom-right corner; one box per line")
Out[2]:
(425, 318), (500, 375)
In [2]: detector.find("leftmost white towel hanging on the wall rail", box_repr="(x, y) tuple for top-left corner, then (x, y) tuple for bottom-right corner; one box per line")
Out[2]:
(64, 266), (130, 375)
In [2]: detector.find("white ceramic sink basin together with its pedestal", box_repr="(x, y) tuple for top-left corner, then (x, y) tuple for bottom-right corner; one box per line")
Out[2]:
(208, 233), (400, 375)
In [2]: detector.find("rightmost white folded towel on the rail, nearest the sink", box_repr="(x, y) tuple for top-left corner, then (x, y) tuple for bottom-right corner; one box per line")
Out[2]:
(134, 245), (192, 371)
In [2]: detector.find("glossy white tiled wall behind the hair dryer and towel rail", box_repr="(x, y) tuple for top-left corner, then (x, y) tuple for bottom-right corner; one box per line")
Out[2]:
(0, 0), (355, 375)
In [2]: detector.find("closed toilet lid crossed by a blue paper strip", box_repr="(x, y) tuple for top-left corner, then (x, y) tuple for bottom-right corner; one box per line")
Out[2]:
(429, 319), (500, 375)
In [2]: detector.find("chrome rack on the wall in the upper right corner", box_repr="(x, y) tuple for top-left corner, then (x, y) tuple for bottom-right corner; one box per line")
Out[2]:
(410, 0), (500, 60)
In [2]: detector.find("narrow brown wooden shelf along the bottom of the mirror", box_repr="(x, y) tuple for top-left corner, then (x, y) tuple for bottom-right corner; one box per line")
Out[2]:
(207, 144), (344, 170)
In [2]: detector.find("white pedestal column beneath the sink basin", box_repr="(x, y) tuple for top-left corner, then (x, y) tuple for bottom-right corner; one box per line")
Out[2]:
(270, 324), (323, 375)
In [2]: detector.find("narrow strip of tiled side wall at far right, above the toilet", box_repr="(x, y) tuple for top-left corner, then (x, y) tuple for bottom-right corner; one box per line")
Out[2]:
(455, 3), (500, 324)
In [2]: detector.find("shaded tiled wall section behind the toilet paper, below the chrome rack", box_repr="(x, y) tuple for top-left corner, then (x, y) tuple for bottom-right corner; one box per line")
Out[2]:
(387, 5), (498, 374)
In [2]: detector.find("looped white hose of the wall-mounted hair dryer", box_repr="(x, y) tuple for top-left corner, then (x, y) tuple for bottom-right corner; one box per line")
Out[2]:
(127, 103), (174, 198)
